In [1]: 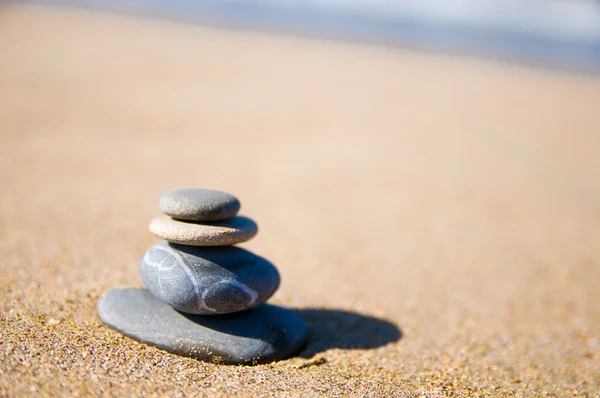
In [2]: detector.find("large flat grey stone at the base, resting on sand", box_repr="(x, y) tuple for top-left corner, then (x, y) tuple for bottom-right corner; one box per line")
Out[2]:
(98, 288), (308, 365)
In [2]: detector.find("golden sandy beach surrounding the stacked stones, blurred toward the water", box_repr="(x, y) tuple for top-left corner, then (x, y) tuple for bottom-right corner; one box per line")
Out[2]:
(0, 4), (600, 397)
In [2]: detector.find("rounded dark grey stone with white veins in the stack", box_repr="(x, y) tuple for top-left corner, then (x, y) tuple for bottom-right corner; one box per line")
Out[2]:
(140, 242), (280, 315)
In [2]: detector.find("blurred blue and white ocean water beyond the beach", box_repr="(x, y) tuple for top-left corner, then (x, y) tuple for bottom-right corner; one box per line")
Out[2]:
(25, 0), (600, 71)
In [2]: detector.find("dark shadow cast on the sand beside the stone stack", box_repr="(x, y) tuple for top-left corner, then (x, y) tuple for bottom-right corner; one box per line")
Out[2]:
(294, 308), (403, 358)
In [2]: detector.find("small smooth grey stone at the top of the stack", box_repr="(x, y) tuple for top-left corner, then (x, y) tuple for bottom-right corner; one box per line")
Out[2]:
(158, 189), (240, 221)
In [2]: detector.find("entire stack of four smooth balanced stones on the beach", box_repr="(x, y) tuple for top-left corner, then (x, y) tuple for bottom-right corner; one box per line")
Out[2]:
(98, 189), (307, 364)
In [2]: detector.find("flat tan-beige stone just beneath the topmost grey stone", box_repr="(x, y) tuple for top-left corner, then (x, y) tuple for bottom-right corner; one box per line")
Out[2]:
(150, 216), (258, 246)
